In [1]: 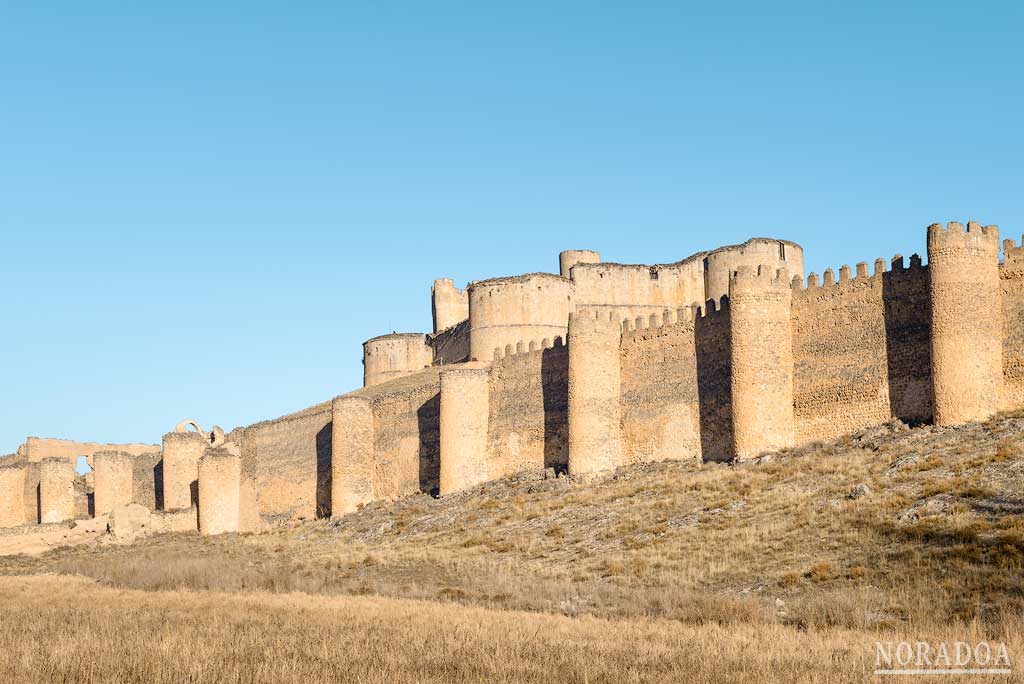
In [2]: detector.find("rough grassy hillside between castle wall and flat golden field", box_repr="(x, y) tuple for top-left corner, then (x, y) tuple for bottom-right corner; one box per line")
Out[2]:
(0, 414), (1024, 681)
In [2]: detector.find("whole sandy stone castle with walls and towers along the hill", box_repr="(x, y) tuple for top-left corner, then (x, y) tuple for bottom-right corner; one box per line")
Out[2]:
(0, 223), (1024, 533)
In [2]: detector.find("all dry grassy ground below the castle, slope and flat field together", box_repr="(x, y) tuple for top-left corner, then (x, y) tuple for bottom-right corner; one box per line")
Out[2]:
(0, 414), (1024, 682)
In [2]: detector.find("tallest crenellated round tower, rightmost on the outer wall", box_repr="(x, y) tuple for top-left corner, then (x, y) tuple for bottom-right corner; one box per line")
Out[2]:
(928, 222), (1002, 425)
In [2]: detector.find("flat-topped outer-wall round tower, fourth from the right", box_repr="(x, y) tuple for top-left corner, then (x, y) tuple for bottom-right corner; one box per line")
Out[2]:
(440, 368), (490, 496)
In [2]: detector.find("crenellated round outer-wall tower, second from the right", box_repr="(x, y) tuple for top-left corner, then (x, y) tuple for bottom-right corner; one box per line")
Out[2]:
(729, 265), (794, 459)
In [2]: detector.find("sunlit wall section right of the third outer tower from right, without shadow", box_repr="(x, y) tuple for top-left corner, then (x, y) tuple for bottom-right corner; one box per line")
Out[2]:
(620, 308), (700, 463)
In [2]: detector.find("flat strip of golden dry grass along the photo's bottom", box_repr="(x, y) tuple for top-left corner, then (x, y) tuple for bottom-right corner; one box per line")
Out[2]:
(0, 576), (1024, 684)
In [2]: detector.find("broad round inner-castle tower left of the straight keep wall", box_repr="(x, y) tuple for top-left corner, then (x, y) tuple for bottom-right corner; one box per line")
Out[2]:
(469, 273), (574, 360)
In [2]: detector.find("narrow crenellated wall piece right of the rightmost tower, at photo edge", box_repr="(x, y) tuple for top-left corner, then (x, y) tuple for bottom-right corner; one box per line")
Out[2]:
(999, 239), (1024, 411)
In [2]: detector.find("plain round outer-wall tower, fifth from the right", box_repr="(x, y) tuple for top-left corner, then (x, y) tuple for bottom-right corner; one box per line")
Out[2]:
(331, 396), (376, 517)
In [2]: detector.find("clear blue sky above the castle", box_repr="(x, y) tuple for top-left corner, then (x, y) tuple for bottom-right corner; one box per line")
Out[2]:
(0, 0), (1024, 453)
